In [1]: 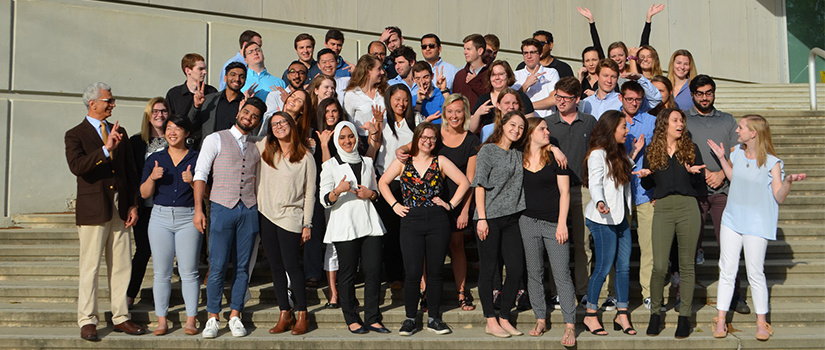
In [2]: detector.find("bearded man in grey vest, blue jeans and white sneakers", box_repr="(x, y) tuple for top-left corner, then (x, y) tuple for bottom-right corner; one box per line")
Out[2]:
(193, 97), (266, 338)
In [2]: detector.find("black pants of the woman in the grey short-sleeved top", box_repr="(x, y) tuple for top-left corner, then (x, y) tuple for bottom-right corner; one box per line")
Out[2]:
(476, 214), (524, 319)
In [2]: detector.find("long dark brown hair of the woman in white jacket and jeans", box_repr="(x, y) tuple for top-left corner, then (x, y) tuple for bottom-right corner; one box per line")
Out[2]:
(582, 111), (633, 188)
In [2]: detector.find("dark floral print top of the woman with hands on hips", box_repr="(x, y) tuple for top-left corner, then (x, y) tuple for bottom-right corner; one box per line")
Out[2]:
(401, 157), (442, 208)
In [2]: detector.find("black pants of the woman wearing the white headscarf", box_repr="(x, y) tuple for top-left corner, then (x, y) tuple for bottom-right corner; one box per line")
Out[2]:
(335, 236), (383, 325)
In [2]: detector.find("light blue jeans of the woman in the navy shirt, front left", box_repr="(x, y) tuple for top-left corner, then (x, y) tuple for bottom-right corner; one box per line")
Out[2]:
(148, 205), (201, 317)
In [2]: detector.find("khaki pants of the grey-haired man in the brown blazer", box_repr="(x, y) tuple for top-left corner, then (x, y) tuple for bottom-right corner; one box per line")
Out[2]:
(77, 194), (132, 327)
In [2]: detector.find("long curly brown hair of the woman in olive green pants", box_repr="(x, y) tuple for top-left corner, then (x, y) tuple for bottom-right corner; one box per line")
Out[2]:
(645, 108), (696, 172)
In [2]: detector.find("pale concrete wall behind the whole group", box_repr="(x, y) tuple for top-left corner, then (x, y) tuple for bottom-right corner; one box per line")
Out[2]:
(0, 0), (787, 218)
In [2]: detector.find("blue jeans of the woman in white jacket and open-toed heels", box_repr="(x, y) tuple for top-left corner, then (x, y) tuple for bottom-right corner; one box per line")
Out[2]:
(585, 218), (633, 310)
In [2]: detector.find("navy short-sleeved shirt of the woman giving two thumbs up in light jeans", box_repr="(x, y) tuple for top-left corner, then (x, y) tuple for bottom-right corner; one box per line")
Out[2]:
(140, 148), (198, 208)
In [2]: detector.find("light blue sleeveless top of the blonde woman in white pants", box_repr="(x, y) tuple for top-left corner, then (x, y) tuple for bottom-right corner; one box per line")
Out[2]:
(722, 145), (785, 241)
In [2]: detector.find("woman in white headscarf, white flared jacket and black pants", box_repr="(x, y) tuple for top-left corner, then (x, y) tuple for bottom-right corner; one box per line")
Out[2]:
(319, 121), (389, 334)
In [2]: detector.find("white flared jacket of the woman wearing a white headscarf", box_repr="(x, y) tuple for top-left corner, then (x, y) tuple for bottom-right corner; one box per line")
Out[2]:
(319, 157), (386, 244)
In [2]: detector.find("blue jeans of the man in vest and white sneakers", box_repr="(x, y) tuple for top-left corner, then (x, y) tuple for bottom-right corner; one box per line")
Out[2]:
(206, 202), (258, 314)
